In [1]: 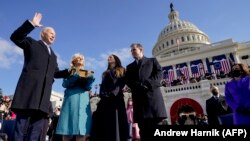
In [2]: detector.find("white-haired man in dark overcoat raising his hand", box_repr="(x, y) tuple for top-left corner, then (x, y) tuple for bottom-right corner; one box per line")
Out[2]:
(10, 13), (68, 141)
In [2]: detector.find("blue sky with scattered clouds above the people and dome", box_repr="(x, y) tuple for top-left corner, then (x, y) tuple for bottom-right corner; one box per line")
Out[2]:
(0, 0), (250, 95)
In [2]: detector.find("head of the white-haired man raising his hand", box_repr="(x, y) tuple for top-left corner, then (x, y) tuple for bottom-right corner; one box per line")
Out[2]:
(41, 28), (56, 45)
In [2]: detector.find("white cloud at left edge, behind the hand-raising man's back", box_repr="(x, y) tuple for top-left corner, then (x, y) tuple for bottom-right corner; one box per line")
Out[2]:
(0, 38), (23, 69)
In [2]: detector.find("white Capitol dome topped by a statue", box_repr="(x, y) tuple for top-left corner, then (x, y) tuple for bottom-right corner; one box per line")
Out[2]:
(153, 4), (210, 58)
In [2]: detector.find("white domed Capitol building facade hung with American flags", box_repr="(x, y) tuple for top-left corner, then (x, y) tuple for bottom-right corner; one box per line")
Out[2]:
(51, 4), (250, 123)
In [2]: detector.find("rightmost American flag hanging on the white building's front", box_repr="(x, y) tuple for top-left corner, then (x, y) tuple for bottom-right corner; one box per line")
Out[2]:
(214, 58), (230, 74)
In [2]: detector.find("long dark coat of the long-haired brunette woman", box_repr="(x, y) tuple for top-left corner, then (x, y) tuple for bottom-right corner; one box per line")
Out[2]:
(90, 70), (128, 141)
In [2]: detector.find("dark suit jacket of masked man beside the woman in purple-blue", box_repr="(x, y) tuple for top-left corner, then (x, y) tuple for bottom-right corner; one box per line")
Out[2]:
(206, 95), (232, 125)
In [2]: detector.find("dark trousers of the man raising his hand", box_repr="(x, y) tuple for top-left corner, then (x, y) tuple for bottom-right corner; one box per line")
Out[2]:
(13, 114), (47, 141)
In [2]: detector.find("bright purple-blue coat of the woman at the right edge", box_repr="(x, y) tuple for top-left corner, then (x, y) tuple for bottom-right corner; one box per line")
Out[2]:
(225, 76), (250, 125)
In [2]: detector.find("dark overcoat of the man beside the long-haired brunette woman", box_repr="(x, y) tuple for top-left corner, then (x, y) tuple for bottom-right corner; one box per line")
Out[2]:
(125, 57), (167, 122)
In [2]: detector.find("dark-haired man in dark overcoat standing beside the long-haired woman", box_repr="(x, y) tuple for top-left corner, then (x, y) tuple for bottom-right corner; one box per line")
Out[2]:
(125, 43), (167, 141)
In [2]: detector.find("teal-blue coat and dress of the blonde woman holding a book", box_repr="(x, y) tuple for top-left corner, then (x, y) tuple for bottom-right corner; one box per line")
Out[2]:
(56, 74), (95, 135)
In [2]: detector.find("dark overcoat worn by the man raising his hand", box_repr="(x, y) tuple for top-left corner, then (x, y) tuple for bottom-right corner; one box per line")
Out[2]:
(10, 21), (67, 115)
